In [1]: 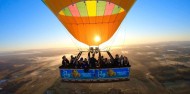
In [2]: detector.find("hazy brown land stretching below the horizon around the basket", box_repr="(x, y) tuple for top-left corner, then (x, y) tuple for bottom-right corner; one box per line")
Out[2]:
(0, 42), (190, 94)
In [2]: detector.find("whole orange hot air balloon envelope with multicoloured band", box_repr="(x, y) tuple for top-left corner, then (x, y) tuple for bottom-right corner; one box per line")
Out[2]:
(43, 0), (136, 46)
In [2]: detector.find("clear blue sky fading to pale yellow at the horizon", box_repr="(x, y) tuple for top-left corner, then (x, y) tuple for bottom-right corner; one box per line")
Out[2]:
(0, 0), (190, 51)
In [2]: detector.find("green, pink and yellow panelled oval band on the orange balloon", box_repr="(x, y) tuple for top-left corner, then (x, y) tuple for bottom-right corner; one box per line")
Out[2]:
(59, 1), (125, 17)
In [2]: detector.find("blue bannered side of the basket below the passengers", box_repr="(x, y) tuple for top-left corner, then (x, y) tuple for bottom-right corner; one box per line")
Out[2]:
(60, 67), (130, 83)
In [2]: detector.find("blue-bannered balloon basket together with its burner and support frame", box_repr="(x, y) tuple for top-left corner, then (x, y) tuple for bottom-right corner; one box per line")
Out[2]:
(60, 47), (131, 83)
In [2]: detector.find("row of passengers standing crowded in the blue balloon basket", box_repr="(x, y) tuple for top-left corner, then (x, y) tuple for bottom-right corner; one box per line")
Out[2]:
(60, 54), (130, 69)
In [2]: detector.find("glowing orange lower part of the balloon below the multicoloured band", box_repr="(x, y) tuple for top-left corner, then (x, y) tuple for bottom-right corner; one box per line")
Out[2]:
(58, 12), (126, 46)
